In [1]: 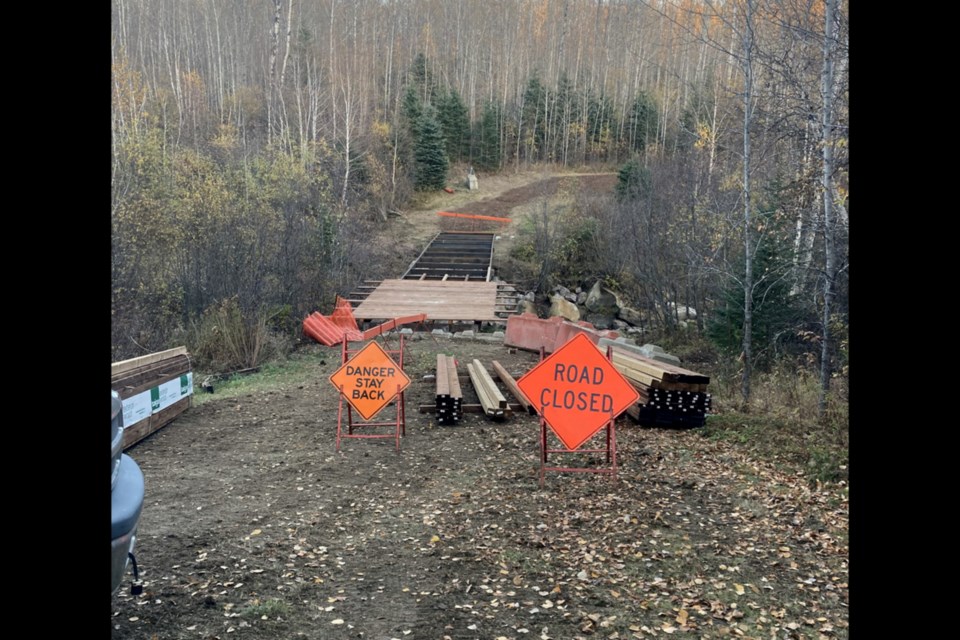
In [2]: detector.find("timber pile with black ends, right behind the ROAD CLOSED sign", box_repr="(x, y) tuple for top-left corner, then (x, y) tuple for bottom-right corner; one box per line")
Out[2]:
(612, 347), (711, 429)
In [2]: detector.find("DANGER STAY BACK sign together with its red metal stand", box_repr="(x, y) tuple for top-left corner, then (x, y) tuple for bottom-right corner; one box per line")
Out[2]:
(330, 335), (410, 451)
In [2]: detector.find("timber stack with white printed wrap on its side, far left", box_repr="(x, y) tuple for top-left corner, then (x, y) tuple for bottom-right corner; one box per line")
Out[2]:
(110, 347), (193, 449)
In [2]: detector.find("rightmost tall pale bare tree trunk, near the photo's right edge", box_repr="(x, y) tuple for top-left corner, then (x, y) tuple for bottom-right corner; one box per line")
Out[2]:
(818, 0), (837, 418)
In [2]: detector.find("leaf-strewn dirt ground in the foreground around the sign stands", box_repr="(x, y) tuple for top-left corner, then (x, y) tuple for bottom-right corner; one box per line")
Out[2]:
(111, 336), (848, 640)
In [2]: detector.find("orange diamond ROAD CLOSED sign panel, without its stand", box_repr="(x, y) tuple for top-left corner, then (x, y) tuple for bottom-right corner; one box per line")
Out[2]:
(517, 333), (640, 451)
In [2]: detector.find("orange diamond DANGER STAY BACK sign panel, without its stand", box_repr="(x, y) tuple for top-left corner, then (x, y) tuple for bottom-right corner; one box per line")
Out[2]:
(330, 342), (410, 420)
